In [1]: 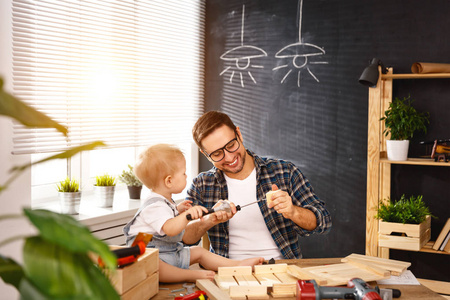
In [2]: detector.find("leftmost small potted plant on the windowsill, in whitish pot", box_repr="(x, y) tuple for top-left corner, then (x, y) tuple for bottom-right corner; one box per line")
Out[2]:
(56, 177), (81, 215)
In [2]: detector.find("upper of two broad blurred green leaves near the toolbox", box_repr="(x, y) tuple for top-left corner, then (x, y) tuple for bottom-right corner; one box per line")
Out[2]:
(24, 208), (117, 269)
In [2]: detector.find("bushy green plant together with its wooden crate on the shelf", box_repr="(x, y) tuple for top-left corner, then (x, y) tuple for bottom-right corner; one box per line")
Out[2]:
(375, 195), (434, 251)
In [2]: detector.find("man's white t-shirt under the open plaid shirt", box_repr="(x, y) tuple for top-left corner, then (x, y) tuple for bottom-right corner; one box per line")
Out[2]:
(225, 169), (283, 260)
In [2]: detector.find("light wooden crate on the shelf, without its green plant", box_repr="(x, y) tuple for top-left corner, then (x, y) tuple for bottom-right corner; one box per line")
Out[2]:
(378, 216), (431, 251)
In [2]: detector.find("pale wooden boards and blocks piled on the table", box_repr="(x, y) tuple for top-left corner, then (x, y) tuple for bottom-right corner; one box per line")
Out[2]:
(197, 254), (411, 300)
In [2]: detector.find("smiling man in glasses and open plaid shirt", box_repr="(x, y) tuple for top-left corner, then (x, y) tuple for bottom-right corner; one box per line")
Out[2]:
(183, 111), (331, 259)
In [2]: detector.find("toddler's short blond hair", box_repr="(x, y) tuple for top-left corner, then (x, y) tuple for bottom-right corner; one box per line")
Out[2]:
(134, 144), (184, 189)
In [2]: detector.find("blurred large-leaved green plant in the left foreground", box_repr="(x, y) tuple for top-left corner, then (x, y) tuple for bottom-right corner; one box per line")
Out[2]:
(0, 78), (120, 299)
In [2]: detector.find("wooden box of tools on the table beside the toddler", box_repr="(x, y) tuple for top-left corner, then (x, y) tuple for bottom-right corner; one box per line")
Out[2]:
(109, 246), (159, 300)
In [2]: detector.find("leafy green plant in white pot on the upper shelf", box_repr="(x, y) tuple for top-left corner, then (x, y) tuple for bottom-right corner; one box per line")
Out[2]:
(380, 96), (430, 160)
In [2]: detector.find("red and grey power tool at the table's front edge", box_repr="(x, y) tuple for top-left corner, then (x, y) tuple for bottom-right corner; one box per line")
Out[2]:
(297, 278), (383, 300)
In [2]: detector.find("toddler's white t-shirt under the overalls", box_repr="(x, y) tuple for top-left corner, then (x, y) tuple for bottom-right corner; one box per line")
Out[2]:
(130, 192), (177, 235)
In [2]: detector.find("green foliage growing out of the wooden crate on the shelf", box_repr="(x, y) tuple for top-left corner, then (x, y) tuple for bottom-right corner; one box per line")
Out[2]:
(375, 195), (432, 224)
